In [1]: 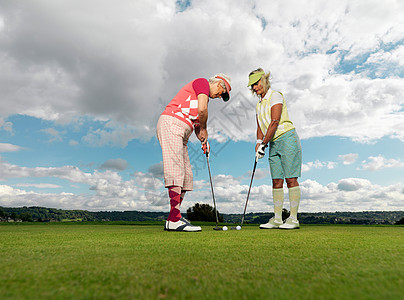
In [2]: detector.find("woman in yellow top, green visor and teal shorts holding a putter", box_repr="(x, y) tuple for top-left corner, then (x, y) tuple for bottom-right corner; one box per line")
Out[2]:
(248, 68), (302, 229)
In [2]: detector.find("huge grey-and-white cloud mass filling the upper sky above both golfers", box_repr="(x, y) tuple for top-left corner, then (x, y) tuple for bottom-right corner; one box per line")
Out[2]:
(0, 0), (404, 147)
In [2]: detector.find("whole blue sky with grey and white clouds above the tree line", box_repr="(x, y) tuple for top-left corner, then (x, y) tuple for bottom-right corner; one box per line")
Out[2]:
(0, 0), (404, 213)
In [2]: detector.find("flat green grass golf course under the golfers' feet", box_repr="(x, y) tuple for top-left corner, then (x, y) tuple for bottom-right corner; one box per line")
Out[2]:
(0, 224), (404, 300)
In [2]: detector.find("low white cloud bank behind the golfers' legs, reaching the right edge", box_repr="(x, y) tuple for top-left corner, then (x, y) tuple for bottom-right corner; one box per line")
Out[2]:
(183, 178), (404, 213)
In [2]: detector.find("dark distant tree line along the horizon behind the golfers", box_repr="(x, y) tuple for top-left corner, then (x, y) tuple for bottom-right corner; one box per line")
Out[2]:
(0, 203), (404, 225)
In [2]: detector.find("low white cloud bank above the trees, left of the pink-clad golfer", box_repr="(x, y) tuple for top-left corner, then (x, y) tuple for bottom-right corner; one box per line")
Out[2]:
(0, 156), (169, 211)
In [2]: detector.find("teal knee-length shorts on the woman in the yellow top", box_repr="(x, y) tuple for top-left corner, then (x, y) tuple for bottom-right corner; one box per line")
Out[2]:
(268, 129), (302, 179)
